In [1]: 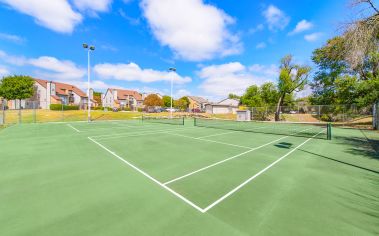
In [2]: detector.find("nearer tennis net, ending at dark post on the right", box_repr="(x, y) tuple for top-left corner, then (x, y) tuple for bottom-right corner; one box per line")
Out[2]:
(194, 118), (331, 140)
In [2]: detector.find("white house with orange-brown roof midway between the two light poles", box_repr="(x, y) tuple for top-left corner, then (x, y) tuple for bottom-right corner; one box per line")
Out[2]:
(102, 88), (143, 111)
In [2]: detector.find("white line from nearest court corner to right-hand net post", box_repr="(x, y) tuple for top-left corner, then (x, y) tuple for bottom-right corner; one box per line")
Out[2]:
(203, 130), (323, 212)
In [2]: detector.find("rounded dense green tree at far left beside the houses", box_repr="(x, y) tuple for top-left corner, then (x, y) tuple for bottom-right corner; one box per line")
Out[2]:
(0, 75), (34, 109)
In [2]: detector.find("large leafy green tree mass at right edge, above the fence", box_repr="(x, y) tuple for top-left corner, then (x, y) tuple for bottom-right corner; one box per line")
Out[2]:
(310, 36), (379, 107)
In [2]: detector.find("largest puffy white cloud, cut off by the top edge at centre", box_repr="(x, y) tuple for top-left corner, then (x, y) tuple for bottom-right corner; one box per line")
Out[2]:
(141, 0), (242, 61)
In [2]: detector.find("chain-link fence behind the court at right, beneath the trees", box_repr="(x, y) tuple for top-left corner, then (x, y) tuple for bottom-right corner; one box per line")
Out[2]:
(250, 105), (373, 126)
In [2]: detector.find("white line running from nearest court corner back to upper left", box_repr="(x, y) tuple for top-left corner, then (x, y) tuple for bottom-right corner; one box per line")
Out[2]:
(88, 137), (204, 213)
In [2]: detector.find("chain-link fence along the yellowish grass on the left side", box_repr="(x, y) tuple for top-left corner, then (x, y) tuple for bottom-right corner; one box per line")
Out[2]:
(0, 101), (145, 125)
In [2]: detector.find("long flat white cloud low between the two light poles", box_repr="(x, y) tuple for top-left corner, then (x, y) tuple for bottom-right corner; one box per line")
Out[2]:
(94, 63), (191, 83)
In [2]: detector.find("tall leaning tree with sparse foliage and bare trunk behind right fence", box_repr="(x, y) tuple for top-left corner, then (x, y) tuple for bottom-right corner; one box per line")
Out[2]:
(275, 55), (311, 121)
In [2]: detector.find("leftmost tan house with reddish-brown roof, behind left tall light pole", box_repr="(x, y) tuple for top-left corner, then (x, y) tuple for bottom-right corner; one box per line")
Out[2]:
(8, 79), (91, 109)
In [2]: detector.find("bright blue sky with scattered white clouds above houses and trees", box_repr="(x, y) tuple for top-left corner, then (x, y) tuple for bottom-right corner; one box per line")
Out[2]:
(0, 0), (349, 101)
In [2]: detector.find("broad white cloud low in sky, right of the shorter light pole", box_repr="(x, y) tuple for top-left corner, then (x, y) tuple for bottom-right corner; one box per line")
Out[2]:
(198, 62), (277, 99)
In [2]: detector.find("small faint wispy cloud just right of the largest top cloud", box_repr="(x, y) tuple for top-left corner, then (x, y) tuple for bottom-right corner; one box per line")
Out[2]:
(262, 5), (290, 31)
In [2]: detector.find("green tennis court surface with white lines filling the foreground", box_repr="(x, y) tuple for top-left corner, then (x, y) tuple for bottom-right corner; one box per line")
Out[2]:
(0, 119), (379, 236)
